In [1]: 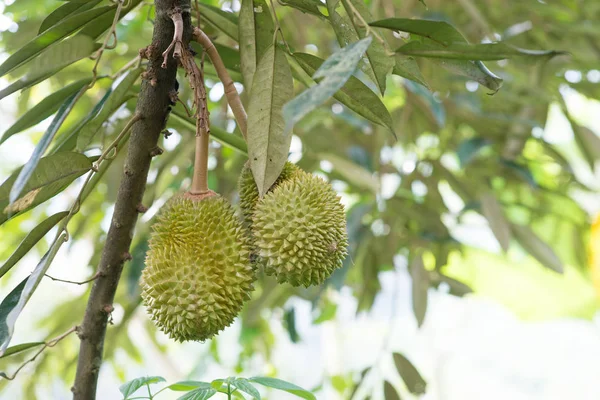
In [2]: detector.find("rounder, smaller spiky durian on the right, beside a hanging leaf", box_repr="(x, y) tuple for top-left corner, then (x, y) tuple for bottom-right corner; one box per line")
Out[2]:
(252, 171), (348, 286)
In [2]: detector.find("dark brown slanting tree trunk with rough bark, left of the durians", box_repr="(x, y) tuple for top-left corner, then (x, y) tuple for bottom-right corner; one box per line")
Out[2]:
(72, 0), (192, 400)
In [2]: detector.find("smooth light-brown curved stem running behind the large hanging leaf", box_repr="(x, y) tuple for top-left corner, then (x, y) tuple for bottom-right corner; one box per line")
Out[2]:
(192, 27), (248, 140)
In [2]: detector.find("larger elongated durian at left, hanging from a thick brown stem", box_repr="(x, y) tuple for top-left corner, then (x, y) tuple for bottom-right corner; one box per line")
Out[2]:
(141, 193), (255, 341)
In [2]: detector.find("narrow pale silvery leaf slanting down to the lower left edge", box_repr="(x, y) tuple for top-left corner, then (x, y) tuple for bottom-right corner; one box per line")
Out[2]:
(0, 238), (64, 356)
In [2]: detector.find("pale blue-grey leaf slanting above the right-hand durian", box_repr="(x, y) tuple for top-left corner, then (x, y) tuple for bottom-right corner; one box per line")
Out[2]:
(283, 37), (372, 130)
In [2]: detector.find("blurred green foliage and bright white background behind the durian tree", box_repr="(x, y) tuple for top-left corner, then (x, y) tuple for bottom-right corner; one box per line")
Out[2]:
(0, 0), (600, 400)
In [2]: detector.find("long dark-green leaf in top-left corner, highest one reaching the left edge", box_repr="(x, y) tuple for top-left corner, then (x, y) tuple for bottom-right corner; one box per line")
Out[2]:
(0, 6), (114, 77)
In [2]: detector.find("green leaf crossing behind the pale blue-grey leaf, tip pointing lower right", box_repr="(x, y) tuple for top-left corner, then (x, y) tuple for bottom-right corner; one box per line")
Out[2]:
(294, 53), (395, 132)
